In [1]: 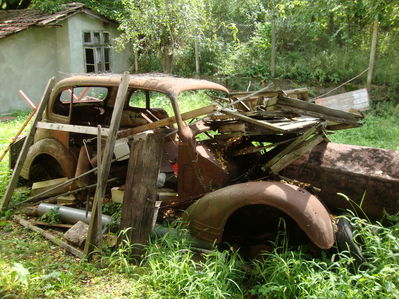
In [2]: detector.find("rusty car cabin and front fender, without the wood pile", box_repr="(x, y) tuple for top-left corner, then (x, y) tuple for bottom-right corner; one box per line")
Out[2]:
(21, 74), (340, 249)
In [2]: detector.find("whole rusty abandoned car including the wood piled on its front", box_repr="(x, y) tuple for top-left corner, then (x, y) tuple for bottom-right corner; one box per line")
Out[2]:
(5, 74), (399, 258)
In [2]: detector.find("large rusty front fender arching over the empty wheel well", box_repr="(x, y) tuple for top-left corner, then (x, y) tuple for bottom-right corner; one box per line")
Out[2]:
(183, 182), (334, 249)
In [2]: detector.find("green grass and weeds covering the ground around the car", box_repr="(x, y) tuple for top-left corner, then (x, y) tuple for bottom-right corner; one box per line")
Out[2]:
(0, 101), (399, 298)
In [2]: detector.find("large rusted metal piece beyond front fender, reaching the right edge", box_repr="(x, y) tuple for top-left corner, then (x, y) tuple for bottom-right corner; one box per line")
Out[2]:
(282, 142), (399, 219)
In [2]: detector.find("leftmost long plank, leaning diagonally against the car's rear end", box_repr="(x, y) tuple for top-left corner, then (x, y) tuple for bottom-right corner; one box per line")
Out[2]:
(0, 77), (55, 211)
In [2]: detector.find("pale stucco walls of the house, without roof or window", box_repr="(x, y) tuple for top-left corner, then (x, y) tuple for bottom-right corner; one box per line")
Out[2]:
(0, 13), (129, 115)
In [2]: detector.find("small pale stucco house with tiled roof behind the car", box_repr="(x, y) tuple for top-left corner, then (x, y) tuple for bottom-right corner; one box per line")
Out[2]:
(0, 2), (130, 115)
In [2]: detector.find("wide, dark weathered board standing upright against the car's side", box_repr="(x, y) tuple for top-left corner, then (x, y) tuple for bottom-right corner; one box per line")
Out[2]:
(120, 133), (164, 257)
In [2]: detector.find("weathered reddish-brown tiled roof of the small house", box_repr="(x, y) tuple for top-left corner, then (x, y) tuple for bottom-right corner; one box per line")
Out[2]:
(0, 2), (106, 39)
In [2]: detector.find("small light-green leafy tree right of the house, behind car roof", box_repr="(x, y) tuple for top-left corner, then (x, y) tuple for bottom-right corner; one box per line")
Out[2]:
(118, 0), (209, 73)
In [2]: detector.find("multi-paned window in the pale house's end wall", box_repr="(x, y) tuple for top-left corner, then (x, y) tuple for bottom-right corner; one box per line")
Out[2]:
(83, 31), (111, 73)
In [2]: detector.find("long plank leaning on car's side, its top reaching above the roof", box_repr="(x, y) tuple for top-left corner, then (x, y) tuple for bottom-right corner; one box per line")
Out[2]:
(84, 72), (130, 258)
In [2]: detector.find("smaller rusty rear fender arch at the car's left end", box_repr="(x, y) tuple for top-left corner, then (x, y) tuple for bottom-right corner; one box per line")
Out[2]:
(21, 138), (76, 180)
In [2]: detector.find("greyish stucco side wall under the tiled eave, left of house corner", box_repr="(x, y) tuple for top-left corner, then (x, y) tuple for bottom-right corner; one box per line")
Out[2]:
(0, 28), (56, 114)
